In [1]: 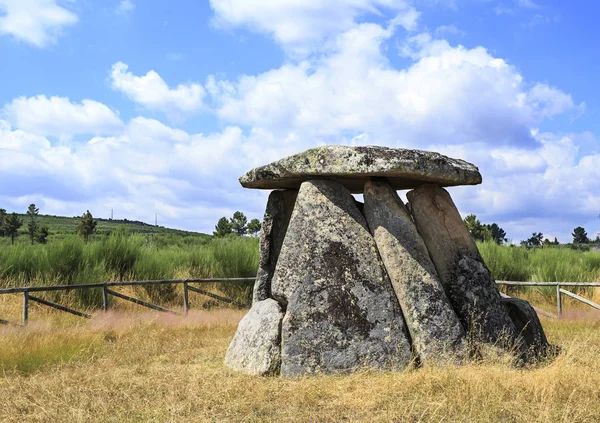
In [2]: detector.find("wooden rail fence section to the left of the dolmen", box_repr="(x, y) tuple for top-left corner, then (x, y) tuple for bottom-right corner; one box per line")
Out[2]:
(0, 278), (256, 326)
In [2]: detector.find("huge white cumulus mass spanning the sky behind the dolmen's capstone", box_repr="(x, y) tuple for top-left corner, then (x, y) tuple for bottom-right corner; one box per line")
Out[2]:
(0, 0), (600, 241)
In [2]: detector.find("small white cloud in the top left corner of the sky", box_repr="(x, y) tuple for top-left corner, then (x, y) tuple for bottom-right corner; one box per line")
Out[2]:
(0, 0), (78, 47)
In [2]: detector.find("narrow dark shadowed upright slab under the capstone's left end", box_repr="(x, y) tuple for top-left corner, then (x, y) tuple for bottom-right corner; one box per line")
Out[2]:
(252, 190), (298, 303)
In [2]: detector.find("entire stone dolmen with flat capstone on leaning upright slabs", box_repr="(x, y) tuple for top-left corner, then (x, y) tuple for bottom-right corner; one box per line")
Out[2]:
(225, 145), (549, 377)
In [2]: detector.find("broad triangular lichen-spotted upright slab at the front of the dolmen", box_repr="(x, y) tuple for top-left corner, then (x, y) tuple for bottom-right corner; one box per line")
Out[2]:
(271, 180), (410, 376)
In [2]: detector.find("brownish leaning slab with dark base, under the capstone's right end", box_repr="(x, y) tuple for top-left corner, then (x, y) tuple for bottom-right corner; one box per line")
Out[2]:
(407, 185), (517, 345)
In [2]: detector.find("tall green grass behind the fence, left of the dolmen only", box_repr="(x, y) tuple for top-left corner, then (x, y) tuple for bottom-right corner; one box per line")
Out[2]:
(0, 234), (258, 308)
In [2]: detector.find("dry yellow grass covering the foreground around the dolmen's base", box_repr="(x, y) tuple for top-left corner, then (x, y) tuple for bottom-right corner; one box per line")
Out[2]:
(0, 310), (600, 423)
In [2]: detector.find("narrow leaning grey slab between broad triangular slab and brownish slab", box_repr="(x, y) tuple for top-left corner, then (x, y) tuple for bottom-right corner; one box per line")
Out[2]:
(364, 180), (466, 363)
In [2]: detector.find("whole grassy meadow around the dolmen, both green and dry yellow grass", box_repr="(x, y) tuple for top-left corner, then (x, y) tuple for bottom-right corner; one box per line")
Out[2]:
(0, 229), (600, 422)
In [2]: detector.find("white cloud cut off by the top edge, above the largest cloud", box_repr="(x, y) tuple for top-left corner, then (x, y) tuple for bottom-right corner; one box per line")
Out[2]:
(210, 0), (419, 54)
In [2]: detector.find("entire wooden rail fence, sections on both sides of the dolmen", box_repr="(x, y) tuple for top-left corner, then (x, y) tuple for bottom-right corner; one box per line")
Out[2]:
(0, 278), (600, 325)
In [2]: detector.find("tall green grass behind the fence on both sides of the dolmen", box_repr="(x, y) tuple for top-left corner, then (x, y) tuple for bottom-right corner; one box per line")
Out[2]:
(0, 237), (600, 308)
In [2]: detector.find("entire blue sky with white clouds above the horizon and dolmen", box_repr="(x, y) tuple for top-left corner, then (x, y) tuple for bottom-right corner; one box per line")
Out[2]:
(0, 0), (600, 242)
